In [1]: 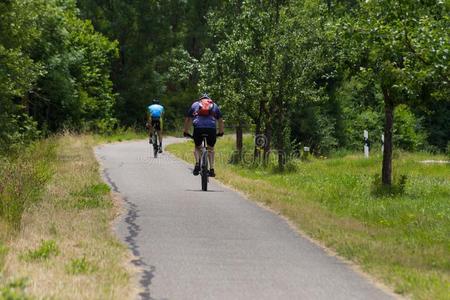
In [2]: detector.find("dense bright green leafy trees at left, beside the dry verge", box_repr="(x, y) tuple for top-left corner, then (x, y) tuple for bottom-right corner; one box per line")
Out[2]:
(0, 0), (117, 152)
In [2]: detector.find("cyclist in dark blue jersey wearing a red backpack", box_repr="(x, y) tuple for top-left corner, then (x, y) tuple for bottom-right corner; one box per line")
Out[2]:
(183, 94), (224, 177)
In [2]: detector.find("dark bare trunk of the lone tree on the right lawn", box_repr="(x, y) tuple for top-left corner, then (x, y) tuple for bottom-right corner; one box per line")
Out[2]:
(381, 89), (394, 186)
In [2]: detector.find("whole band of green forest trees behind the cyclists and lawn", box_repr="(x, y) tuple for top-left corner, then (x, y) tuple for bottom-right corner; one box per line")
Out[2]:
(0, 0), (450, 184)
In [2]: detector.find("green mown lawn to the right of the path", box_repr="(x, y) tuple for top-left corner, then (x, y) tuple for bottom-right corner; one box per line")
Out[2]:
(168, 138), (450, 299)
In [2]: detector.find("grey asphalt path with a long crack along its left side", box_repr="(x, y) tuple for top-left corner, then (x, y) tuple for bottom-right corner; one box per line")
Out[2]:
(95, 138), (393, 300)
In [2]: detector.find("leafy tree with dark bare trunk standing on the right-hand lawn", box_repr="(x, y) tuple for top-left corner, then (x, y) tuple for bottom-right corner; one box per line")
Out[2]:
(340, 0), (450, 186)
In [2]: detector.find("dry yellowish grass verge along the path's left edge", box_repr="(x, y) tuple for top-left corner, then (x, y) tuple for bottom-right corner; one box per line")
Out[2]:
(2, 135), (137, 299)
